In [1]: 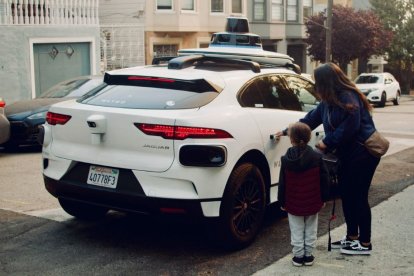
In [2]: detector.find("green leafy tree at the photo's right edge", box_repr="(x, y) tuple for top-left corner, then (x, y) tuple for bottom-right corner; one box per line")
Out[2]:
(370, 0), (414, 94)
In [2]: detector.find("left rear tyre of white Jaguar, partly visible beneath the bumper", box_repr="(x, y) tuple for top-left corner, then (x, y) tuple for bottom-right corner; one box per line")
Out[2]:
(59, 198), (108, 220)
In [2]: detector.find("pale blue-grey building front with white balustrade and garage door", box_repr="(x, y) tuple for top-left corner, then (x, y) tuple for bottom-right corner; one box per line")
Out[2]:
(0, 0), (100, 103)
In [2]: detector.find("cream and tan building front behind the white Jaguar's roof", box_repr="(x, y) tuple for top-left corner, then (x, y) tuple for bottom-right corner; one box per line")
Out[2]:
(145, 0), (248, 64)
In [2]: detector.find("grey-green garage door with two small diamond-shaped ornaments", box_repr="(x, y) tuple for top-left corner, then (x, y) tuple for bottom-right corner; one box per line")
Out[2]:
(33, 42), (91, 97)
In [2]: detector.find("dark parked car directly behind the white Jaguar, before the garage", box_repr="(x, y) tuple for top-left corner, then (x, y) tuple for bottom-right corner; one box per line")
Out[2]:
(3, 76), (103, 148)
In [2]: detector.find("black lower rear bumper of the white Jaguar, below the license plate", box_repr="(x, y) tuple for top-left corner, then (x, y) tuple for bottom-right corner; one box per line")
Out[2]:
(43, 176), (210, 217)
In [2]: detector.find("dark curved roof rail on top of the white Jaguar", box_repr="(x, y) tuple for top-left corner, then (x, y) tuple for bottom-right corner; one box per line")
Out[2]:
(168, 55), (260, 73)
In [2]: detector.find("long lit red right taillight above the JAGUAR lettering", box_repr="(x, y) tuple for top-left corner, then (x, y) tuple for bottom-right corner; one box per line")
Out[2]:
(135, 123), (233, 140)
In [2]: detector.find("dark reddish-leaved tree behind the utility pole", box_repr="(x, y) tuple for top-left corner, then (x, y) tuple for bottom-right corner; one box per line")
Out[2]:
(305, 5), (392, 69)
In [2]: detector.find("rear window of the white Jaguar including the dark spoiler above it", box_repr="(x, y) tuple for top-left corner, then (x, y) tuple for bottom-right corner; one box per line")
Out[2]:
(78, 74), (221, 109)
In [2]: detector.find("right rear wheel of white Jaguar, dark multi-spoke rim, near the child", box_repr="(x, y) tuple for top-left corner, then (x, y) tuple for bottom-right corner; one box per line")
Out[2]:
(219, 163), (266, 249)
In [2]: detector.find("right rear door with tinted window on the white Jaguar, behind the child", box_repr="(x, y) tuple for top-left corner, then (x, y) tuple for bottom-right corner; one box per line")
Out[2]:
(239, 74), (323, 202)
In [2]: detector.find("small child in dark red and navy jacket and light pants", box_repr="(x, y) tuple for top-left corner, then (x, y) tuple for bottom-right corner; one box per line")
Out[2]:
(278, 122), (328, 266)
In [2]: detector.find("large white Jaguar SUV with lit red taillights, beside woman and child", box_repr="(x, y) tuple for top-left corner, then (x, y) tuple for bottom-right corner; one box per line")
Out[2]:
(39, 52), (323, 248)
